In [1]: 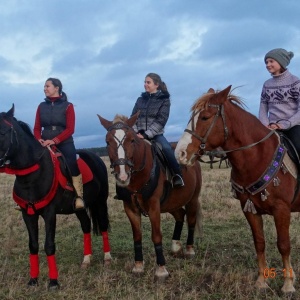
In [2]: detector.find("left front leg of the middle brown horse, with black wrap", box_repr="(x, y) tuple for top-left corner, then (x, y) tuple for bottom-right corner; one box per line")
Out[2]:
(123, 201), (144, 275)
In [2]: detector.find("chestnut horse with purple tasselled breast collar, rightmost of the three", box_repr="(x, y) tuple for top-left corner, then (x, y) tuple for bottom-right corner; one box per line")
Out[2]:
(175, 86), (300, 293)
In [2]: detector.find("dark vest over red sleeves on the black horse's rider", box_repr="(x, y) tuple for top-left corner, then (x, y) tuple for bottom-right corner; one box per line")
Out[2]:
(40, 95), (73, 143)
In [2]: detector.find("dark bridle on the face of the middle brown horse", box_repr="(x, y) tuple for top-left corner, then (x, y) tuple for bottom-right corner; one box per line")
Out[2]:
(107, 122), (146, 174)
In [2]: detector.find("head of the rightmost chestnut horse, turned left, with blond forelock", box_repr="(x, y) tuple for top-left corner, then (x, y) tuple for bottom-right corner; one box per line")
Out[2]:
(175, 85), (234, 165)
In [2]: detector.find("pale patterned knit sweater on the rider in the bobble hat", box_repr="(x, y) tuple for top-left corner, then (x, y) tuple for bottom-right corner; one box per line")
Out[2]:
(259, 70), (300, 129)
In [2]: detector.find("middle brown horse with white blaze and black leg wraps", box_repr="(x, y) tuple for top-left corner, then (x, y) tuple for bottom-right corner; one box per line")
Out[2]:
(98, 114), (202, 281)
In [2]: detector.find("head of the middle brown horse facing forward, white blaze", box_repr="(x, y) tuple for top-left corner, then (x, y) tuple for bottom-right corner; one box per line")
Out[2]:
(97, 112), (144, 187)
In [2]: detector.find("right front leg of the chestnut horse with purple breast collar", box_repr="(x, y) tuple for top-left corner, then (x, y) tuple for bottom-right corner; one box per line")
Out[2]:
(273, 207), (296, 293)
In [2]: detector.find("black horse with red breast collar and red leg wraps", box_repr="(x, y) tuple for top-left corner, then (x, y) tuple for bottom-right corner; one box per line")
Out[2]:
(0, 105), (111, 289)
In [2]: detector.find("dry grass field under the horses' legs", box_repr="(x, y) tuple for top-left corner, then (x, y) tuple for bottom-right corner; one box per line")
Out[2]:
(0, 158), (300, 300)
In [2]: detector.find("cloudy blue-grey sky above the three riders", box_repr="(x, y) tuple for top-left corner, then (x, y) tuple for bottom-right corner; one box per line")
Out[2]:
(0, 0), (300, 148)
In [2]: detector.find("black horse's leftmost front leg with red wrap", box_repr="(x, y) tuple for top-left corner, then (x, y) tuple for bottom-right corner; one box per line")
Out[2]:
(23, 212), (39, 286)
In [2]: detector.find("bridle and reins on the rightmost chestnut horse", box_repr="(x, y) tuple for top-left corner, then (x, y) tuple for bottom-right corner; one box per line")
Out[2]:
(184, 104), (275, 157)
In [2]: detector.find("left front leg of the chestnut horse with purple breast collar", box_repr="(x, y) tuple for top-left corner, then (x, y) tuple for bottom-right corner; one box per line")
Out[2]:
(244, 212), (268, 289)
